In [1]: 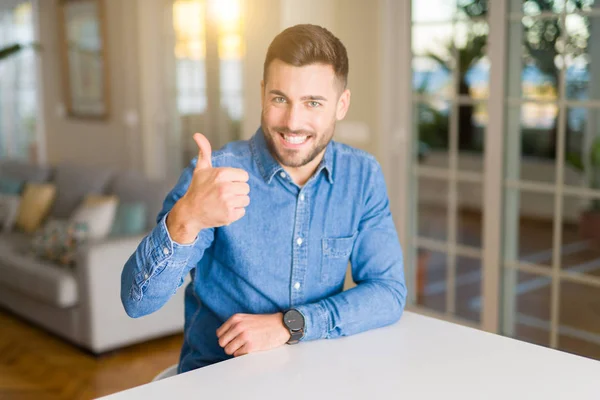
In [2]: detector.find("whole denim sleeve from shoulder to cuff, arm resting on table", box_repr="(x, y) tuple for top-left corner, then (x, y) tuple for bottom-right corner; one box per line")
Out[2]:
(296, 160), (406, 340)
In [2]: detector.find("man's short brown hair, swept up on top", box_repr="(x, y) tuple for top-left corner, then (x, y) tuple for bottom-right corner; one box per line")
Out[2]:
(263, 24), (348, 89)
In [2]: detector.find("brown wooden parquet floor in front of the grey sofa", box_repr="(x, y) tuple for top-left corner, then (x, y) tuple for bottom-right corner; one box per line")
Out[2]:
(0, 310), (183, 400)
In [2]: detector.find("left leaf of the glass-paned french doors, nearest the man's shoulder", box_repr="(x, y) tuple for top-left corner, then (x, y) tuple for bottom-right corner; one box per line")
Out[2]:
(407, 0), (490, 326)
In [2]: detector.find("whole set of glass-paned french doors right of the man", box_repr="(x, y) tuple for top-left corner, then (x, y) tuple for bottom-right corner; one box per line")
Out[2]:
(396, 0), (600, 359)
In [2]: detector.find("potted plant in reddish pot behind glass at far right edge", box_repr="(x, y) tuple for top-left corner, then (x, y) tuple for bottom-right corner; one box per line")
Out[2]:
(579, 137), (600, 244)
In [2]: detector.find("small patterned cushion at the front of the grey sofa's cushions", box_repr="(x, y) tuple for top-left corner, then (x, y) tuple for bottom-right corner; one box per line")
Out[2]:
(31, 220), (88, 267)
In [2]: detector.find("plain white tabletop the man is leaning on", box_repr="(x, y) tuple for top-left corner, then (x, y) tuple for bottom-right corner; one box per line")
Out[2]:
(105, 312), (600, 400)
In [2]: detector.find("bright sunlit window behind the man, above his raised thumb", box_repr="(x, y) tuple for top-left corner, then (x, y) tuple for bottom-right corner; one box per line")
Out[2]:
(173, 0), (244, 166)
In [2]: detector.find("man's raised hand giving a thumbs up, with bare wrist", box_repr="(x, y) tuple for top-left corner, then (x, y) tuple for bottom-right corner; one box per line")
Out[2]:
(167, 133), (250, 244)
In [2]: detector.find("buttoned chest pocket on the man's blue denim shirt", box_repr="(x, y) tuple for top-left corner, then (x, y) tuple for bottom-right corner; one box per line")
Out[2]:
(321, 234), (356, 285)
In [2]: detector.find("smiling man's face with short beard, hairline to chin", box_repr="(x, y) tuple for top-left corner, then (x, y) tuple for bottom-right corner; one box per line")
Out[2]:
(261, 59), (350, 168)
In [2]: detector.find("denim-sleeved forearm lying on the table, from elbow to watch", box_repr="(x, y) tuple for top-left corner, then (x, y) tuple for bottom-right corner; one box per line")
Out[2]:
(296, 279), (406, 341)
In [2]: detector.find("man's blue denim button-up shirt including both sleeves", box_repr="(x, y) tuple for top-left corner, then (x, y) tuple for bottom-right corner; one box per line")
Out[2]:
(121, 129), (406, 372)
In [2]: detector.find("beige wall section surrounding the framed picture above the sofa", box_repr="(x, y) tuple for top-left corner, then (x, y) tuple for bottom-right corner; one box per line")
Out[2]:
(39, 0), (142, 169)
